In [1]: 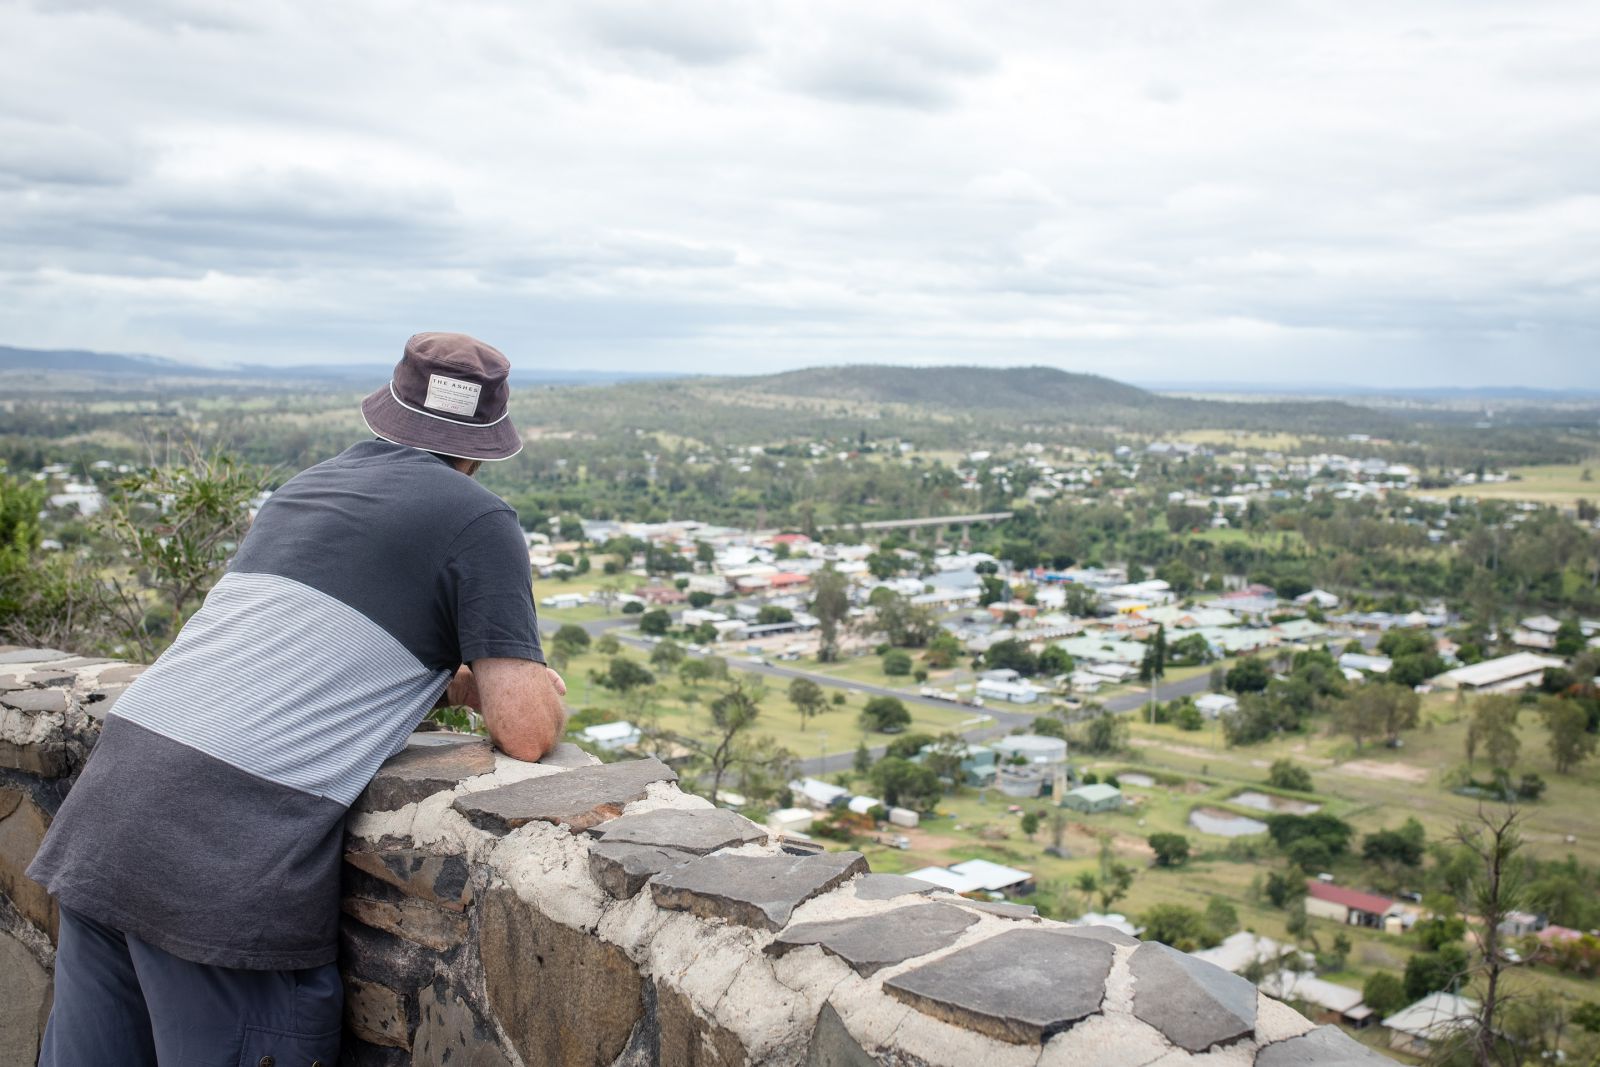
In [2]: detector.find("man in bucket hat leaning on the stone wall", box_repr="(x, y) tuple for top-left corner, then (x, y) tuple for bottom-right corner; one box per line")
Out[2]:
(29, 333), (565, 1067)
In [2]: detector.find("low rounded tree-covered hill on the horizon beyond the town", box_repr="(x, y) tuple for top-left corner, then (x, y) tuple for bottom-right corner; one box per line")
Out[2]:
(729, 365), (1163, 413)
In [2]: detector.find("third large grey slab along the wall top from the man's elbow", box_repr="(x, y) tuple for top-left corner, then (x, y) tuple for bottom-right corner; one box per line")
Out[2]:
(650, 853), (867, 929)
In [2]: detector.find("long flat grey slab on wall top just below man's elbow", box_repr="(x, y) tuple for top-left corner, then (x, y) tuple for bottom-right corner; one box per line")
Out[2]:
(453, 758), (678, 833)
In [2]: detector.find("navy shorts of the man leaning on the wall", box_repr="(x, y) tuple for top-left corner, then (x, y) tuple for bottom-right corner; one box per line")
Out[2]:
(38, 909), (344, 1067)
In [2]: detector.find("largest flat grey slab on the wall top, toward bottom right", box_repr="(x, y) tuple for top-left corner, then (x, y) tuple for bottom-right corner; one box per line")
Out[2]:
(883, 928), (1112, 1045)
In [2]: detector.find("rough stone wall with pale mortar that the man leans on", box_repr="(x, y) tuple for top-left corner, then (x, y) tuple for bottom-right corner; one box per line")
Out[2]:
(0, 648), (1387, 1067)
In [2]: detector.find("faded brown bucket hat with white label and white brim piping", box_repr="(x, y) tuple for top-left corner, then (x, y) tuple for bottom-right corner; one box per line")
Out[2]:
(362, 333), (522, 459)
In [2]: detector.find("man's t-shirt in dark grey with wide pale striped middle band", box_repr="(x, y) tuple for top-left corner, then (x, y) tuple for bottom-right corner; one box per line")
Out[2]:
(29, 442), (544, 969)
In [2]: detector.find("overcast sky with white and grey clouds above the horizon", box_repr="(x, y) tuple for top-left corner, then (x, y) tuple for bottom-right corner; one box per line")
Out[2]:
(0, 0), (1600, 387)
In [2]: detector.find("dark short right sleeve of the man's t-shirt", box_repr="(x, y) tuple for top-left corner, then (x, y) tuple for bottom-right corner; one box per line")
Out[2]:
(442, 510), (544, 664)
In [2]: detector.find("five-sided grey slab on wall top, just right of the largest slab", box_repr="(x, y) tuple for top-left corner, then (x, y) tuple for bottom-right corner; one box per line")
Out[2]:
(1128, 941), (1256, 1053)
